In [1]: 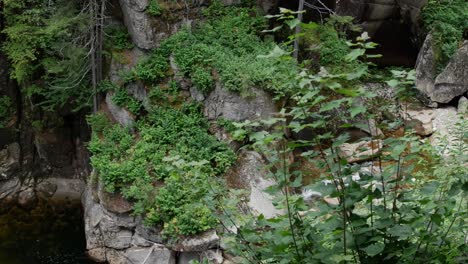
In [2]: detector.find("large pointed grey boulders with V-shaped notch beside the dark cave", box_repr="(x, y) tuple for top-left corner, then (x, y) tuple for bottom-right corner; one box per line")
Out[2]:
(416, 37), (468, 103)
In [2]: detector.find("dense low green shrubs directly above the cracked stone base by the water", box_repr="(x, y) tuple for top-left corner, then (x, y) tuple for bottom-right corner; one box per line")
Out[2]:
(89, 106), (235, 237)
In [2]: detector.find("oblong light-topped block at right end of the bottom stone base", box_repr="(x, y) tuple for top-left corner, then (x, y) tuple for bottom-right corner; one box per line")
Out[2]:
(170, 230), (219, 252)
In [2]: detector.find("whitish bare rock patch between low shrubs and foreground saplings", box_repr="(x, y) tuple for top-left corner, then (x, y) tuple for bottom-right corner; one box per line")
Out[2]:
(226, 151), (282, 218)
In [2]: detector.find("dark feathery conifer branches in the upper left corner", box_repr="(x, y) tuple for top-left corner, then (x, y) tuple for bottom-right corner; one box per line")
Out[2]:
(2, 0), (92, 110)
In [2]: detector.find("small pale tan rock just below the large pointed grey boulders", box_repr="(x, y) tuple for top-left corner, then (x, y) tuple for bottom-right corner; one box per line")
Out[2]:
(402, 109), (435, 136)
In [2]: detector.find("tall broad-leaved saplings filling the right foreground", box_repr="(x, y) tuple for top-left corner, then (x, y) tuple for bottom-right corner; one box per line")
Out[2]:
(215, 19), (468, 263)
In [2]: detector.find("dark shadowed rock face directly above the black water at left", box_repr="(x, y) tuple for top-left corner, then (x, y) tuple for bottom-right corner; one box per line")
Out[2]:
(0, 29), (89, 210)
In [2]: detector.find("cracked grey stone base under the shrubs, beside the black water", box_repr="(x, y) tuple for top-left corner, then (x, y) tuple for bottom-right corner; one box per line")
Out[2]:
(82, 183), (223, 264)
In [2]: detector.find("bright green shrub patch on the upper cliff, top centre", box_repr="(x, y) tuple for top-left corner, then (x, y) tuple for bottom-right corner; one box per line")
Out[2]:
(162, 4), (296, 95)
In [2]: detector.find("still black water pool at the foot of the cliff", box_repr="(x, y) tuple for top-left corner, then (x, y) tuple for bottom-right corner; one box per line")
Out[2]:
(0, 201), (93, 264)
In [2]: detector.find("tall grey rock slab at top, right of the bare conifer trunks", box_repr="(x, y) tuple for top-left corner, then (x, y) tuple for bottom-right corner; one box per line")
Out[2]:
(119, 0), (157, 50)
